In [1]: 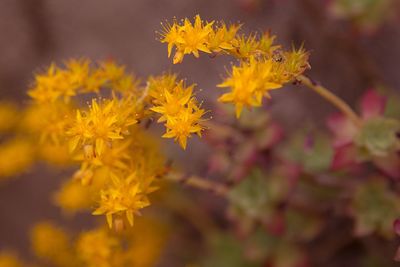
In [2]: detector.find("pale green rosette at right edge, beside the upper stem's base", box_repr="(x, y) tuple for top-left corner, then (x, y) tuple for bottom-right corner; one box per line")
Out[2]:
(355, 118), (400, 156)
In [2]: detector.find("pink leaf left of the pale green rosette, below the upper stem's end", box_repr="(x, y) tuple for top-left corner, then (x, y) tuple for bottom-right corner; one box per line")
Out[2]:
(327, 114), (358, 147)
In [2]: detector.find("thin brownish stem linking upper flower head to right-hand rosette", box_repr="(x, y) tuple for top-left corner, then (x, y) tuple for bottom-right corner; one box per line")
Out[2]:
(296, 75), (362, 126)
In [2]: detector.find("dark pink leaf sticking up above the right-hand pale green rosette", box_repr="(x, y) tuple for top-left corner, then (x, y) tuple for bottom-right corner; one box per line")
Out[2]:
(361, 89), (387, 119)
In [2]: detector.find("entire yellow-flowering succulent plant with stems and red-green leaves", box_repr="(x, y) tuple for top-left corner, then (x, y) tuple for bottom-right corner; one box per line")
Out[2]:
(0, 15), (400, 267)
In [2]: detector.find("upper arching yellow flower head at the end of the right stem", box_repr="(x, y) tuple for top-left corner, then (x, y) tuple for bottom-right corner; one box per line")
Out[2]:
(161, 15), (309, 117)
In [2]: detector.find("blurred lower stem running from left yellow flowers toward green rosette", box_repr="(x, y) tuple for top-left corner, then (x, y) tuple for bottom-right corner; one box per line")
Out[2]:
(166, 173), (229, 197)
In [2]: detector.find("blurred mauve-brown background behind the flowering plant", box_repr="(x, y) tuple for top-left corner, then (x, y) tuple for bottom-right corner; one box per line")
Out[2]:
(0, 0), (400, 266)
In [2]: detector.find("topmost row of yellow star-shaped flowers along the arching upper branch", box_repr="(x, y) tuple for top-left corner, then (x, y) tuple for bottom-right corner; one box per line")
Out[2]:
(160, 15), (280, 64)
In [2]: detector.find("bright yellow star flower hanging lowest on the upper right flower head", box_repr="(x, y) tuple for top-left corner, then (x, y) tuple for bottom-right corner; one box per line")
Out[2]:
(218, 58), (282, 117)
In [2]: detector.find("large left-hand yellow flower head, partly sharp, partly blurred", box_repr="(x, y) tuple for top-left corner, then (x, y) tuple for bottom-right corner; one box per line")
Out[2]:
(17, 59), (205, 229)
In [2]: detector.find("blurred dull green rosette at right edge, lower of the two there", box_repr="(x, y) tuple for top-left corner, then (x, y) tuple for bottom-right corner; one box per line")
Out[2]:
(352, 179), (400, 237)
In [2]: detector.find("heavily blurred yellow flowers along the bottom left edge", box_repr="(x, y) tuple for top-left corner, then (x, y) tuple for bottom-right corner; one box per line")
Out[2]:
(25, 220), (169, 267)
